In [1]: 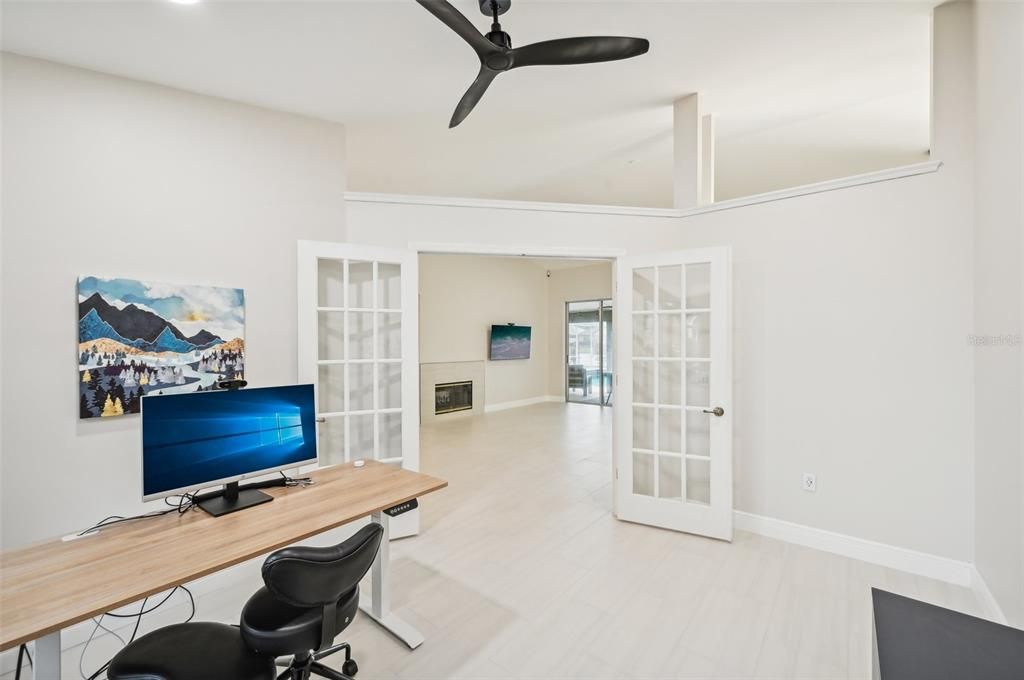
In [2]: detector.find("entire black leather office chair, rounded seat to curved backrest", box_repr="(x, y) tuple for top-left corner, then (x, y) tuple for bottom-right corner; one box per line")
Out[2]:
(106, 524), (384, 680)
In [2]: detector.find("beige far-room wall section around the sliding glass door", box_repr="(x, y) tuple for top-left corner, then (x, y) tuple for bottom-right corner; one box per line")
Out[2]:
(548, 261), (614, 396)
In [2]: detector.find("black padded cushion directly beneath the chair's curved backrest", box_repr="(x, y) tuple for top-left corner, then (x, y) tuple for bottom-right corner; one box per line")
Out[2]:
(241, 586), (359, 656)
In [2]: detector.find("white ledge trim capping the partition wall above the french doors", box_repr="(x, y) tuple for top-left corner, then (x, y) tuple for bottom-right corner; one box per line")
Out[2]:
(345, 161), (943, 219)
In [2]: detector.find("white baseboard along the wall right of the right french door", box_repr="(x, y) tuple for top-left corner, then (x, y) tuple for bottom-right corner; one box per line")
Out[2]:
(734, 510), (975, 587)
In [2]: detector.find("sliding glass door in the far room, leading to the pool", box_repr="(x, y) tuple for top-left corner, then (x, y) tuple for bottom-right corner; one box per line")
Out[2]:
(565, 300), (614, 406)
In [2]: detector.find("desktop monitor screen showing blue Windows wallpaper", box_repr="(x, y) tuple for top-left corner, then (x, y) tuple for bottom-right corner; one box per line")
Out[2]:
(142, 385), (316, 501)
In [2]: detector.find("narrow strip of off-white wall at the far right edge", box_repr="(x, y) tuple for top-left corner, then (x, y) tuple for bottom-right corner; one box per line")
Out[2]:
(972, 2), (1024, 627)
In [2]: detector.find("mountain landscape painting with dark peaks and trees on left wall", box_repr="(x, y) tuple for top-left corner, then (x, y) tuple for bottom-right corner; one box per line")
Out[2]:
(78, 277), (245, 419)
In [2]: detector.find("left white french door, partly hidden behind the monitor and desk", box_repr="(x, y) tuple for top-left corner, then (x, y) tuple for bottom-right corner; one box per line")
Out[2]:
(297, 241), (420, 538)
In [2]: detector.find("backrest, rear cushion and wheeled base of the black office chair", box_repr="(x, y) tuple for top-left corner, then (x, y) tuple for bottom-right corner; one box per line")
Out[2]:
(241, 524), (384, 680)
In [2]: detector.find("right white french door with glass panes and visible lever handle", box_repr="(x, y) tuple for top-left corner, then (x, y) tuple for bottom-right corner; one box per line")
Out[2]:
(615, 248), (732, 540)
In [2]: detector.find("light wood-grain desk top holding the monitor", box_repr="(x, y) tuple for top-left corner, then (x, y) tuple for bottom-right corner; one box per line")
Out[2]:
(0, 461), (447, 651)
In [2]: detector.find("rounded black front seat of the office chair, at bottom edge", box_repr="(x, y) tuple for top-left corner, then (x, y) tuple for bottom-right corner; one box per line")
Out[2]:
(106, 623), (276, 680)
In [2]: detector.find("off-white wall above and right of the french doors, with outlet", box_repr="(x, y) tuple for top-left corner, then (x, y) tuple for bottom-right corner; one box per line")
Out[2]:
(348, 151), (972, 560)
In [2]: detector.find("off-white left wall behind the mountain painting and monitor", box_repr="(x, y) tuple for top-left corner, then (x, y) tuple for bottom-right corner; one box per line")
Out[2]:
(0, 54), (345, 548)
